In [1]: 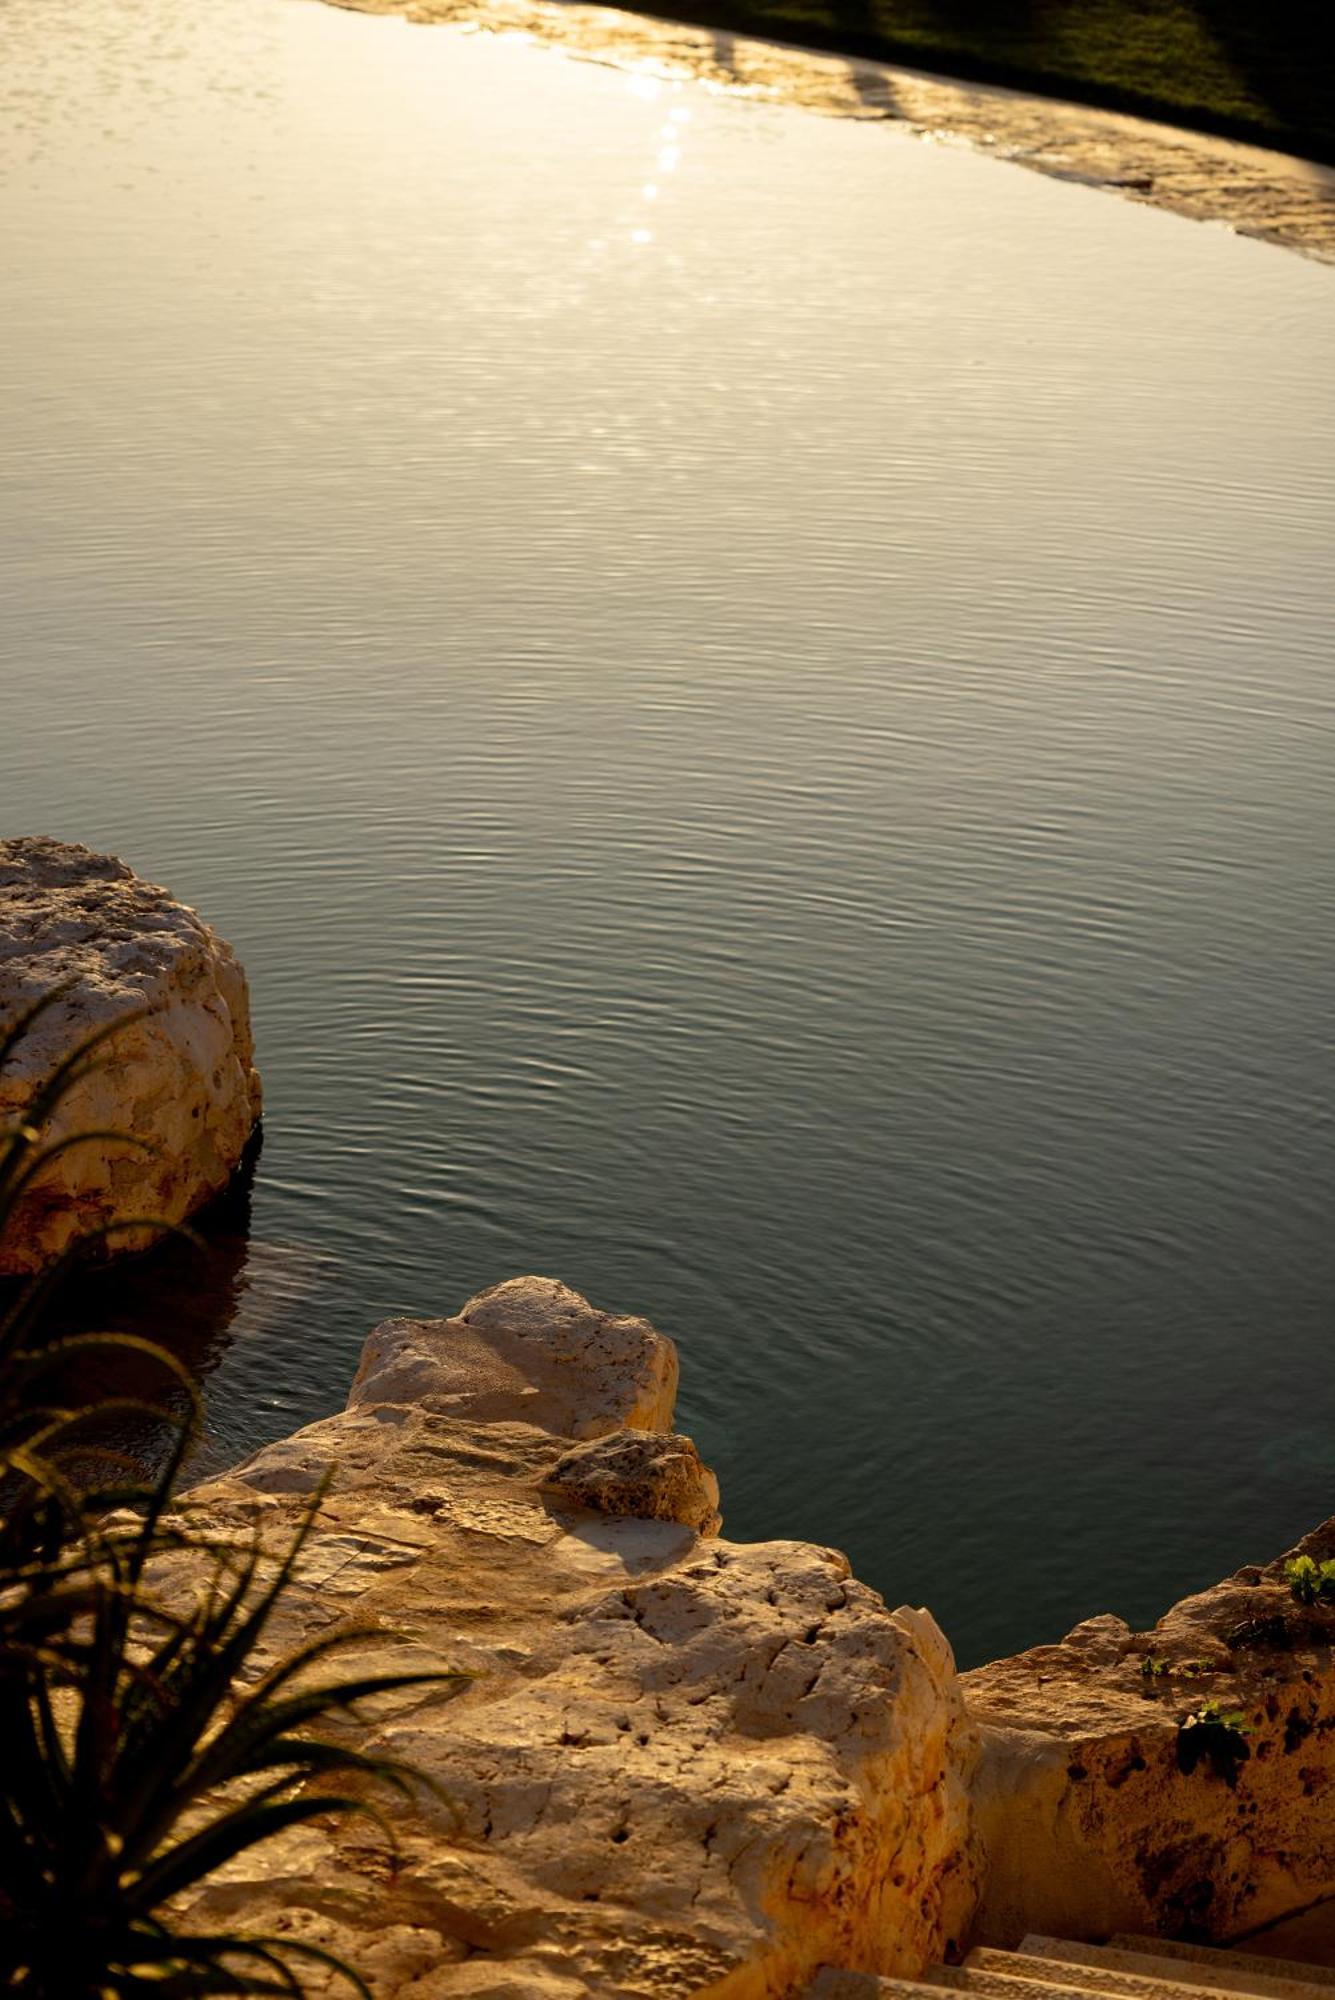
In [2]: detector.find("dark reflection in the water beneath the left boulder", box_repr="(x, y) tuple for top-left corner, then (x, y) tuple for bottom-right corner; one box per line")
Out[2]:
(19, 1134), (328, 1474)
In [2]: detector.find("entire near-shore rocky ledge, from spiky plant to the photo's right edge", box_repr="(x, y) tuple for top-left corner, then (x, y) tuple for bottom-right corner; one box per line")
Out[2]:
(109, 1278), (1335, 2000)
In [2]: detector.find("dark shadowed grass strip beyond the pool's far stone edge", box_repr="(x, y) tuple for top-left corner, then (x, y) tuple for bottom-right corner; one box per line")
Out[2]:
(652, 0), (1335, 160)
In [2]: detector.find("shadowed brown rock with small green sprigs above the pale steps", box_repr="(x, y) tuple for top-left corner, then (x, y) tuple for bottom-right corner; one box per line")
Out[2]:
(963, 1522), (1335, 1950)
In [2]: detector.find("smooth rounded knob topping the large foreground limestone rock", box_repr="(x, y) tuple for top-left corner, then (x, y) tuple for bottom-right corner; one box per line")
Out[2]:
(348, 1278), (677, 1438)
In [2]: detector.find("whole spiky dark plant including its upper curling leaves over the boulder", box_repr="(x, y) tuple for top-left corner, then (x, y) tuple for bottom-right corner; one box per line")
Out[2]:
(0, 994), (464, 2000)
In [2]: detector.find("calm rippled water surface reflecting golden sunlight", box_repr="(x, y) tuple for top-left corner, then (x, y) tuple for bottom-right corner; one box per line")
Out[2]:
(0, 0), (1335, 1662)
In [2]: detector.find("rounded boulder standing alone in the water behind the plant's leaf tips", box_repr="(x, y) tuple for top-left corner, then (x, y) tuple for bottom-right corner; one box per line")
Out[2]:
(0, 838), (260, 1274)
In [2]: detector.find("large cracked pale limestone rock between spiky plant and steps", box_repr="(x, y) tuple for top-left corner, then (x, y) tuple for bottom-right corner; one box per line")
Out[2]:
(171, 1278), (977, 2000)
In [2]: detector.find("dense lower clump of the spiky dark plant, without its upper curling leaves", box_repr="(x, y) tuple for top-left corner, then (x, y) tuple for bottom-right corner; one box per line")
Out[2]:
(0, 1472), (456, 2000)
